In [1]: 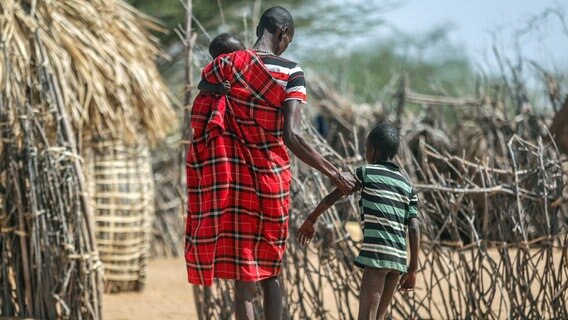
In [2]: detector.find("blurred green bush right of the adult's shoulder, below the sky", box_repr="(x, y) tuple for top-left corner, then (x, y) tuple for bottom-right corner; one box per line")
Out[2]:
(303, 26), (475, 102)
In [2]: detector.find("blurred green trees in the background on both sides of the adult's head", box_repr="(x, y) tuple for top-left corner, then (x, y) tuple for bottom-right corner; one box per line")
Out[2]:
(130, 0), (474, 102)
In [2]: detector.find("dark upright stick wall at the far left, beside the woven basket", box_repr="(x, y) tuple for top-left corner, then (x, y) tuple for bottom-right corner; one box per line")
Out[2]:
(0, 33), (102, 319)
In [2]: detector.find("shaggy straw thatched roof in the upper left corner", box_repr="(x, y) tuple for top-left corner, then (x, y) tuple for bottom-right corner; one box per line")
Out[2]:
(0, 0), (176, 141)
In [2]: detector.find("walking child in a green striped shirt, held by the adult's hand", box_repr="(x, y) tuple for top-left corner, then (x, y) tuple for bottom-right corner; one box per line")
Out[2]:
(298, 122), (420, 320)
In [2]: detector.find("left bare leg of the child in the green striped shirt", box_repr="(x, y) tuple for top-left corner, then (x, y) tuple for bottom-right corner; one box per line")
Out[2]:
(357, 267), (388, 320)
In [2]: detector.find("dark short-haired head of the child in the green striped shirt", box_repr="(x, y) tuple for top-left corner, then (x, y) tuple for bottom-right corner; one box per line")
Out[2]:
(365, 122), (400, 163)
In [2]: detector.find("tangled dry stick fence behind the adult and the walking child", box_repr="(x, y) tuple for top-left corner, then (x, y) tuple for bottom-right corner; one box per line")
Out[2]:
(185, 67), (568, 319)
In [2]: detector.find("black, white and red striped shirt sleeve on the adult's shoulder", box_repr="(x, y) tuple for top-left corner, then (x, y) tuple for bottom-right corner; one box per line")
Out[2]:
(257, 51), (307, 103)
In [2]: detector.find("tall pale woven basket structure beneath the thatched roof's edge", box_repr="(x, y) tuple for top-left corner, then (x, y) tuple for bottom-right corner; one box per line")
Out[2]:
(83, 141), (154, 293)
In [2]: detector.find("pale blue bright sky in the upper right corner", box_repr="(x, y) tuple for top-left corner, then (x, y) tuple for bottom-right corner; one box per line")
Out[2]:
(382, 0), (568, 67)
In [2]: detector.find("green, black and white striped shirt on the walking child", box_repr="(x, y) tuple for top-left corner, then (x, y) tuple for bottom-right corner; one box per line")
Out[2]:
(355, 162), (418, 272)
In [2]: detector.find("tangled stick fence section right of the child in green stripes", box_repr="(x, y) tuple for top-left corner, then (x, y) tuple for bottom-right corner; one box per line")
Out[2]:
(392, 135), (568, 319)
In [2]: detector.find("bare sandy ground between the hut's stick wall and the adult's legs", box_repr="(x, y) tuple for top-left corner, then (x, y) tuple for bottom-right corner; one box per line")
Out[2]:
(103, 257), (197, 320)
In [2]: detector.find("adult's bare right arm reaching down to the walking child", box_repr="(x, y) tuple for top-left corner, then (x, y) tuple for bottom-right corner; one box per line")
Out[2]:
(284, 100), (355, 194)
